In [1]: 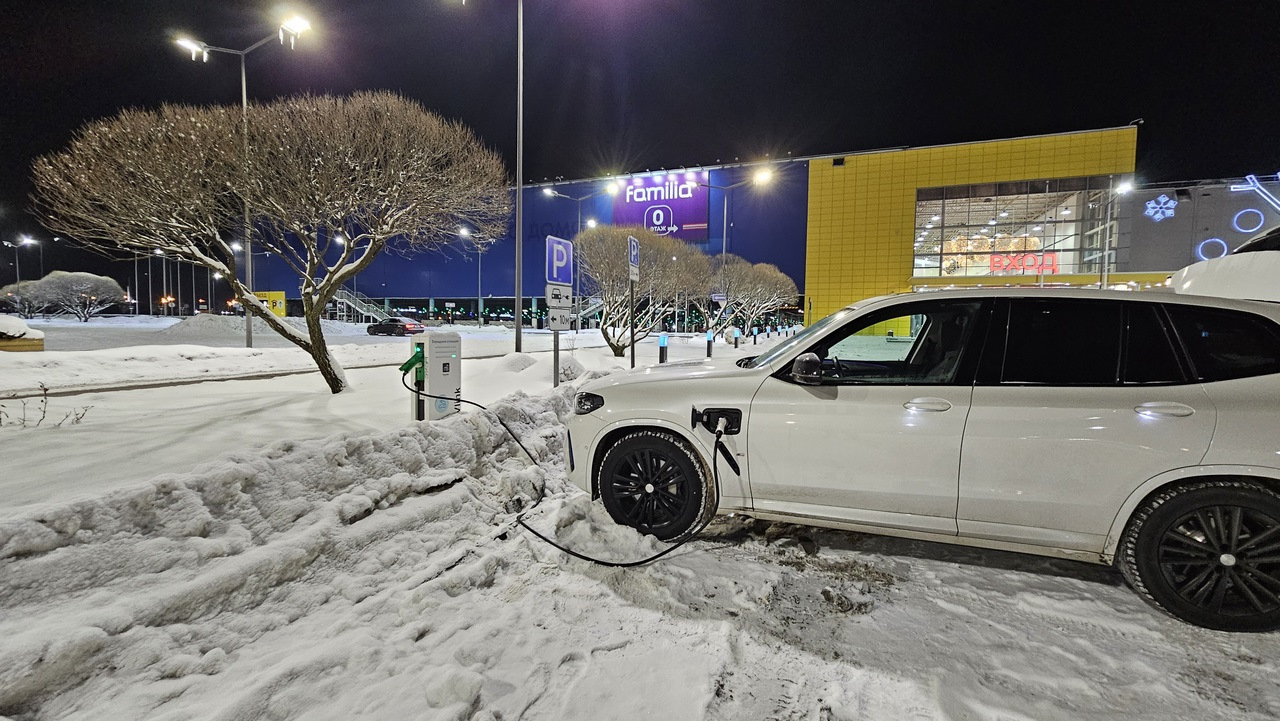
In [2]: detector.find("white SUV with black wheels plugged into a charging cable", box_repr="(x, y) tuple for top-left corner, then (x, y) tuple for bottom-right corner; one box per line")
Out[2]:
(566, 288), (1280, 631)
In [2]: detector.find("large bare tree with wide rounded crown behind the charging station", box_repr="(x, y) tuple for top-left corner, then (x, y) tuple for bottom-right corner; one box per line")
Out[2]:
(33, 92), (511, 393)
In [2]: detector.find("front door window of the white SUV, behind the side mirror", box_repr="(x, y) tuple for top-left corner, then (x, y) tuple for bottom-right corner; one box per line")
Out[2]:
(810, 300), (982, 385)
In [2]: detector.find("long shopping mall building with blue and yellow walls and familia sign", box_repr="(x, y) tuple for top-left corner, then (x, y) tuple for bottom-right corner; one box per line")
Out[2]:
(257, 126), (1280, 319)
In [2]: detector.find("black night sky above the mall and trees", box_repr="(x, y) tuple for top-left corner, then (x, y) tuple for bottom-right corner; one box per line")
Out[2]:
(0, 0), (1280, 283)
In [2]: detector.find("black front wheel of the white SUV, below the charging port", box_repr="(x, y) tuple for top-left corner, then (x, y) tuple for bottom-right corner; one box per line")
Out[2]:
(596, 430), (717, 540)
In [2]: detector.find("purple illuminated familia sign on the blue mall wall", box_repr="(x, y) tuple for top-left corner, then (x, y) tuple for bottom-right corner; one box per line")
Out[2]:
(613, 170), (708, 242)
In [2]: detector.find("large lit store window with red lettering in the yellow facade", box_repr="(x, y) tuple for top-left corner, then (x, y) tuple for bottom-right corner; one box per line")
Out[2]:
(913, 175), (1115, 279)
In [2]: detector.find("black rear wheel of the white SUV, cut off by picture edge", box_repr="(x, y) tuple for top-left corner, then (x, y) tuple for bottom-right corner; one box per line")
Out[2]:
(1116, 479), (1280, 631)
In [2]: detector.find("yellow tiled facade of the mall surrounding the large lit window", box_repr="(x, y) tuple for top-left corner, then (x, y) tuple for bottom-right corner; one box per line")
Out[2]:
(805, 126), (1146, 323)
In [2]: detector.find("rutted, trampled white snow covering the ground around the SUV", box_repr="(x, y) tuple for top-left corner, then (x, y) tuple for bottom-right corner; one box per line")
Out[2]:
(0, 322), (1280, 721)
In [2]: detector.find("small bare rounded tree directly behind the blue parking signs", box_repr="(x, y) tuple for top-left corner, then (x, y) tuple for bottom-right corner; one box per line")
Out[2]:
(573, 225), (710, 357)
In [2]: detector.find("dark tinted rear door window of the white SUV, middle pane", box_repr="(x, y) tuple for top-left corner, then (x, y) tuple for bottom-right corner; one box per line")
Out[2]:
(1000, 298), (1124, 385)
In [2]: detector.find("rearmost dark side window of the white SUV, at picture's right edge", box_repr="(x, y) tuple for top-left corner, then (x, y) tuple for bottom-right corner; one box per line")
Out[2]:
(1165, 304), (1280, 382)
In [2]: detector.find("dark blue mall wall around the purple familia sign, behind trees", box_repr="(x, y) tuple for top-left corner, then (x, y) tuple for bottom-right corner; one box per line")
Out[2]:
(255, 161), (809, 298)
